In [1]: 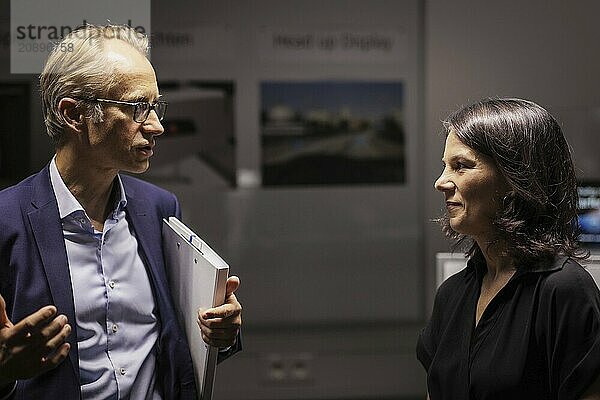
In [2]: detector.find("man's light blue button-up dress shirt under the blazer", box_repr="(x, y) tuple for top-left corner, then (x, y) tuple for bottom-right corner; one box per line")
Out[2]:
(50, 159), (161, 400)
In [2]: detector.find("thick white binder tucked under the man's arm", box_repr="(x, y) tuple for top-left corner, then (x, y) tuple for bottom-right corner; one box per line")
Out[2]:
(162, 217), (229, 400)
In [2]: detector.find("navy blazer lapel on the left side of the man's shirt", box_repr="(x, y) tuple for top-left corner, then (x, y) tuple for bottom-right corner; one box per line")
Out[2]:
(28, 166), (79, 381)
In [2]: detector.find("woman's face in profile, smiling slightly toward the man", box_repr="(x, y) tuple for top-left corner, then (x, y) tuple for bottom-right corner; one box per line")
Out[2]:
(435, 129), (509, 241)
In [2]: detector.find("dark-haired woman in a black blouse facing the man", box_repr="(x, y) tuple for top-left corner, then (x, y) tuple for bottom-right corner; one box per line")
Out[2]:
(417, 99), (600, 400)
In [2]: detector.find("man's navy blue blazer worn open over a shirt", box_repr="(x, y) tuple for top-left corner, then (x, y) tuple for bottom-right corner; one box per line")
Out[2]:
(0, 166), (214, 400)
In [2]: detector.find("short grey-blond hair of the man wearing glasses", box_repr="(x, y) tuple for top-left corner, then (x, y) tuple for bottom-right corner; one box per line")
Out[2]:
(40, 24), (149, 145)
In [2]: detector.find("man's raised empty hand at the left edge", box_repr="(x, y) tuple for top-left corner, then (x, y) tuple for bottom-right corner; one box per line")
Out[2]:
(0, 295), (71, 388)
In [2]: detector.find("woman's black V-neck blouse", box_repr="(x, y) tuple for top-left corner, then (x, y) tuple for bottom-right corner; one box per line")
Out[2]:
(417, 258), (600, 400)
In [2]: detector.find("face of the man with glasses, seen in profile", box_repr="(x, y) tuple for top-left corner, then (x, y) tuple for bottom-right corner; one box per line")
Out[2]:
(87, 40), (164, 173)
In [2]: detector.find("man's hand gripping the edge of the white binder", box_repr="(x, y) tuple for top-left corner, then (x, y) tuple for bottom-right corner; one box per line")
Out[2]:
(198, 276), (242, 348)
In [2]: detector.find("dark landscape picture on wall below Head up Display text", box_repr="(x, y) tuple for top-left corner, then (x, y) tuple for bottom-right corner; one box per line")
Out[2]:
(260, 81), (406, 186)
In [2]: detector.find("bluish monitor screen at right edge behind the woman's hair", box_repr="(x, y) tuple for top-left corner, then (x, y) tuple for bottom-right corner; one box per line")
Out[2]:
(577, 181), (600, 245)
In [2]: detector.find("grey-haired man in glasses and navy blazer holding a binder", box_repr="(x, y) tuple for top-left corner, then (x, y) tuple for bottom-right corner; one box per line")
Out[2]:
(0, 25), (241, 400)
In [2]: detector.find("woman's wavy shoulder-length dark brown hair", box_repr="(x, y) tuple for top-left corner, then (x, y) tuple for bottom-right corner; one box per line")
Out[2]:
(440, 99), (585, 265)
